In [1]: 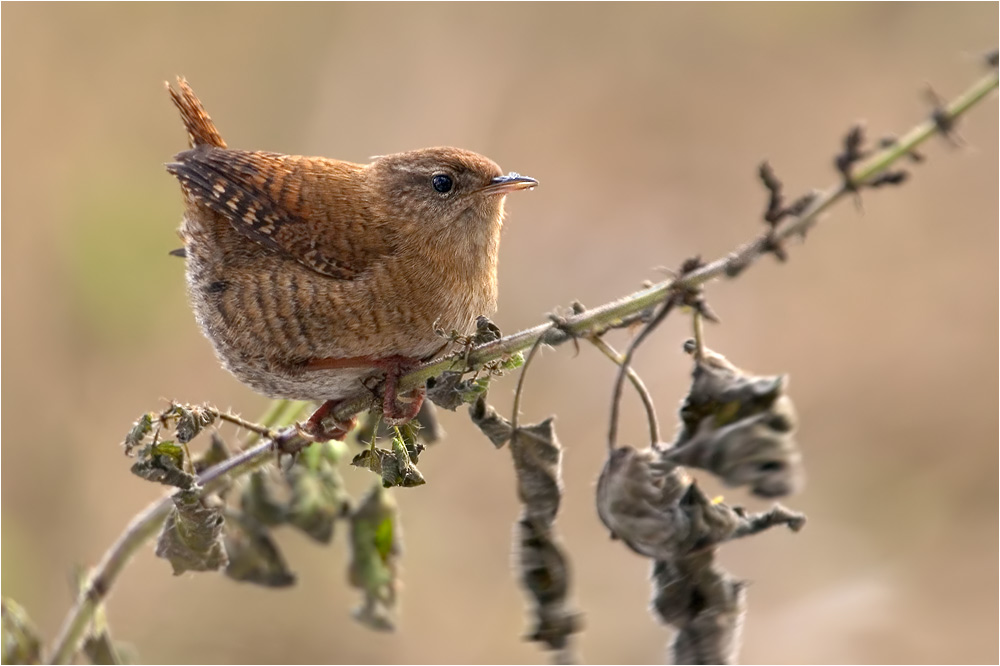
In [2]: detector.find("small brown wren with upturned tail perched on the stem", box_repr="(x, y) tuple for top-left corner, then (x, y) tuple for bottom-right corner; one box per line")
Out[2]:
(166, 78), (538, 439)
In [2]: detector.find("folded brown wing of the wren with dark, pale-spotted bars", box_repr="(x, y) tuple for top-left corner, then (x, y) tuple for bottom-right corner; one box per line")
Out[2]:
(166, 146), (394, 280)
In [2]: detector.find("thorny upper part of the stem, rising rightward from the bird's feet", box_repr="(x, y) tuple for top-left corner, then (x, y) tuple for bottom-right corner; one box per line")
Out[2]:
(326, 70), (997, 420)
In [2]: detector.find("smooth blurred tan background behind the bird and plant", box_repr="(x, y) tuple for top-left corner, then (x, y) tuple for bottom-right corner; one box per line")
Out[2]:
(2, 3), (998, 663)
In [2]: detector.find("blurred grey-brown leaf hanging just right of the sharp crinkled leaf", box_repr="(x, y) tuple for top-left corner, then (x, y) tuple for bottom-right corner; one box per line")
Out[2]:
(225, 515), (295, 587)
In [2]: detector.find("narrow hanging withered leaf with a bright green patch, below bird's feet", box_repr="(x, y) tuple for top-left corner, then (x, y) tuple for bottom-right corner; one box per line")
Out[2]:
(348, 485), (402, 631)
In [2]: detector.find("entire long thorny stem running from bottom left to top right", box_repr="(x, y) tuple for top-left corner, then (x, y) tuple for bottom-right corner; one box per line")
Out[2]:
(49, 63), (998, 664)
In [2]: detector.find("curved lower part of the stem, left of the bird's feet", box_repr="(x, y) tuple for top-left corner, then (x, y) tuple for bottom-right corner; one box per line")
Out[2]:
(49, 401), (309, 664)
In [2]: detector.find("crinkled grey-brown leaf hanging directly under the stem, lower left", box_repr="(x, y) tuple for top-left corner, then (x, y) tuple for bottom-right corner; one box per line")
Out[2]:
(156, 490), (228, 575)
